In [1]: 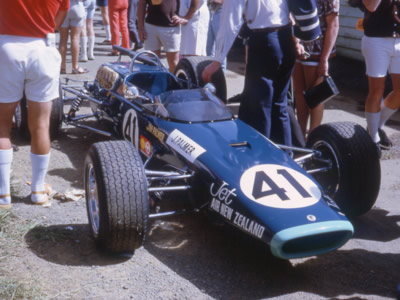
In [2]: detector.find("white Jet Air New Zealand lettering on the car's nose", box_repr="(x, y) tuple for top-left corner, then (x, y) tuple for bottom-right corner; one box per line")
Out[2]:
(210, 181), (265, 239)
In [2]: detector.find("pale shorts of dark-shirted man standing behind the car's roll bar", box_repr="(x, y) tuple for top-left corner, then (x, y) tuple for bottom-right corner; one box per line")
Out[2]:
(144, 23), (181, 52)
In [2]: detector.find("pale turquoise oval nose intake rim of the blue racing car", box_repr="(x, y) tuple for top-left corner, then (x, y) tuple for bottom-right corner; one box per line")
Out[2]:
(270, 221), (354, 259)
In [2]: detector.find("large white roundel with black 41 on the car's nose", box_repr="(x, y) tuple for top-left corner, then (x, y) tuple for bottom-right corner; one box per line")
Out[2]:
(240, 164), (321, 208)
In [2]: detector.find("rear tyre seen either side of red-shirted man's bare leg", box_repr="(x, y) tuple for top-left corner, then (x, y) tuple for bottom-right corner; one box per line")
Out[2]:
(14, 92), (64, 140)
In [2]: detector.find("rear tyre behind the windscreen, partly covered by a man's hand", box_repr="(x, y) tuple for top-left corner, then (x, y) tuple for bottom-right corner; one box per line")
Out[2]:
(175, 56), (227, 103)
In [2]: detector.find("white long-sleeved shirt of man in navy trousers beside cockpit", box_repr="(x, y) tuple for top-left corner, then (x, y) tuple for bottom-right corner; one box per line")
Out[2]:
(215, 0), (289, 63)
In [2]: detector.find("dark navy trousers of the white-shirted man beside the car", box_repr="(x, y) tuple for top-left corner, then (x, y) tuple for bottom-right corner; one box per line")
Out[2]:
(239, 28), (296, 146)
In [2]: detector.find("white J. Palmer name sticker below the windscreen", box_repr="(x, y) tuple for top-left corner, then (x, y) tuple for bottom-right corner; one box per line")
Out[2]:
(167, 129), (206, 163)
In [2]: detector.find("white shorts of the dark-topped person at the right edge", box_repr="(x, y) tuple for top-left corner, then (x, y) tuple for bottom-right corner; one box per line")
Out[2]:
(361, 36), (400, 78)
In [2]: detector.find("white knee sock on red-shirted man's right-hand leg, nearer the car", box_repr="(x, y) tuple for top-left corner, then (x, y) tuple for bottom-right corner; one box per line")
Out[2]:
(31, 152), (50, 202)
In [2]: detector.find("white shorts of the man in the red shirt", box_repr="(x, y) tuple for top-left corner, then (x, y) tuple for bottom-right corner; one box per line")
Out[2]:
(0, 35), (61, 103)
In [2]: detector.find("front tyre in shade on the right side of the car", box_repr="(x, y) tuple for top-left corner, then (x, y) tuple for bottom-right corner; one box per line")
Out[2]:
(306, 122), (381, 217)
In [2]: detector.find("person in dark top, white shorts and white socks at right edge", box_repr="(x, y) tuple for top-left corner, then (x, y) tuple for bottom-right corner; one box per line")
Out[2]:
(361, 0), (400, 154)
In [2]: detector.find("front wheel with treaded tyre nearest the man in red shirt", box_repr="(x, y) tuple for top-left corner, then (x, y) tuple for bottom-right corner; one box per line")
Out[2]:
(84, 141), (149, 255)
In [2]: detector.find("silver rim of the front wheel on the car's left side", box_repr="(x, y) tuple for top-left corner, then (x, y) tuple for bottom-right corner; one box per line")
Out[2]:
(86, 164), (100, 237)
